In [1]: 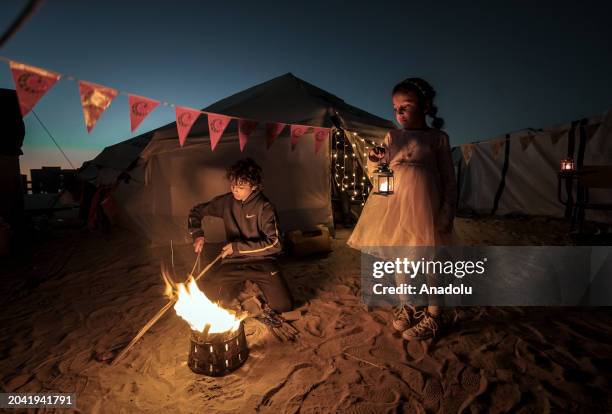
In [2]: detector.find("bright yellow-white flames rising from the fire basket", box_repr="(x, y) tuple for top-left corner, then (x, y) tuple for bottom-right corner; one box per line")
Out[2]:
(162, 270), (240, 333)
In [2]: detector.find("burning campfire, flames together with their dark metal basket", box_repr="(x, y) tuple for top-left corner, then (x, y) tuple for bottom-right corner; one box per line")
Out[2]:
(162, 272), (249, 376)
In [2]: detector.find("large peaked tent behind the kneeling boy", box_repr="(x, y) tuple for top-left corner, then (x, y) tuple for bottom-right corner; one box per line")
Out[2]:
(81, 73), (393, 244)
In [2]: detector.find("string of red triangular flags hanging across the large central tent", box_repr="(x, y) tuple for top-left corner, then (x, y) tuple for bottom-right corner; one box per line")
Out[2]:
(1, 58), (330, 154)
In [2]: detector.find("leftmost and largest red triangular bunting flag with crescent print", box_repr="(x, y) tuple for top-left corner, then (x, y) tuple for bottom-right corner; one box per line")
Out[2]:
(9, 60), (61, 116)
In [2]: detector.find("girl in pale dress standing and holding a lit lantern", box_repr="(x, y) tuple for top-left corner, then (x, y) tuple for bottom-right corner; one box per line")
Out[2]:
(348, 78), (457, 340)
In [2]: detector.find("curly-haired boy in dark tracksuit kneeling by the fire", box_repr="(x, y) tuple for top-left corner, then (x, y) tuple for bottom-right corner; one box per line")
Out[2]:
(188, 158), (293, 313)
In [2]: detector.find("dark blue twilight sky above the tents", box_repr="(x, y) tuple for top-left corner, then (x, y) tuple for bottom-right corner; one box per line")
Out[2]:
(0, 0), (612, 175)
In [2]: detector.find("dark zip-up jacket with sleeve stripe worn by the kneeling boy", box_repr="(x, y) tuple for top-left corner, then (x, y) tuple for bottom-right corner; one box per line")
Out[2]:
(187, 191), (282, 261)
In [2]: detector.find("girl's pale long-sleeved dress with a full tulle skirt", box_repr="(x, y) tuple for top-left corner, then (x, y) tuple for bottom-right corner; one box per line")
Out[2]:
(347, 129), (457, 256)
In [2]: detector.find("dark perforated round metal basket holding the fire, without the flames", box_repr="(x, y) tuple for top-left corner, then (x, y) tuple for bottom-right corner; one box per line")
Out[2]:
(188, 322), (249, 377)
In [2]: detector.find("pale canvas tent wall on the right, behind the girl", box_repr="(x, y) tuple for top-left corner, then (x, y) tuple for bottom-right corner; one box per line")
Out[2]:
(453, 110), (612, 222)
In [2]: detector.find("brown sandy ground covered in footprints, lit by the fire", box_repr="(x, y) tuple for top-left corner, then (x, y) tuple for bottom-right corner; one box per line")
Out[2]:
(0, 218), (612, 413)
